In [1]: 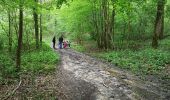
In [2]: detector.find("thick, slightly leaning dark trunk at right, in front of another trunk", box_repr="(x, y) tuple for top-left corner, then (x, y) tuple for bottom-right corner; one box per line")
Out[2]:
(152, 0), (164, 48)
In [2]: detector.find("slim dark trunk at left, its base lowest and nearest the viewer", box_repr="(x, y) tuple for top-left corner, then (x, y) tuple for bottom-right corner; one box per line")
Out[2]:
(16, 0), (23, 72)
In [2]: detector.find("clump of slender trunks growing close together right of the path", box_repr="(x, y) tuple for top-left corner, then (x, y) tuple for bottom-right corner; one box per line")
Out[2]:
(92, 0), (115, 49)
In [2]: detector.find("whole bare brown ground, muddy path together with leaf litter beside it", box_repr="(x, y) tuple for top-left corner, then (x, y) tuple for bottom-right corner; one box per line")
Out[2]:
(0, 49), (170, 100)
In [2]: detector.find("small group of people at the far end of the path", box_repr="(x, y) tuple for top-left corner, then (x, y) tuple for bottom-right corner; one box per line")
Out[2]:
(52, 35), (70, 49)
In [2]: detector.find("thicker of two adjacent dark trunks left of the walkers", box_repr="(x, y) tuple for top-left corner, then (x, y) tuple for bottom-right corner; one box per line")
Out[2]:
(33, 0), (39, 49)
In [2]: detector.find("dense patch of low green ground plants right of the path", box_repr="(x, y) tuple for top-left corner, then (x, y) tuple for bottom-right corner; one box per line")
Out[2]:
(98, 48), (170, 74)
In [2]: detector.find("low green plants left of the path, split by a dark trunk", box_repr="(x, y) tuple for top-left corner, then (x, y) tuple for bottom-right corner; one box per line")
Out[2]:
(0, 44), (59, 84)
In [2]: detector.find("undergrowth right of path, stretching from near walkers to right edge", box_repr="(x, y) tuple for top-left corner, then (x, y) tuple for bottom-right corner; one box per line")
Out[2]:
(73, 38), (170, 78)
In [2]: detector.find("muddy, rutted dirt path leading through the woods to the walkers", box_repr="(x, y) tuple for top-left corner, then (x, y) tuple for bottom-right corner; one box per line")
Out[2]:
(56, 49), (168, 100)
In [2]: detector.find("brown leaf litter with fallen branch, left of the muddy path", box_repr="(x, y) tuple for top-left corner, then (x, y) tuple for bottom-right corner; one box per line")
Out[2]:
(0, 73), (57, 100)
